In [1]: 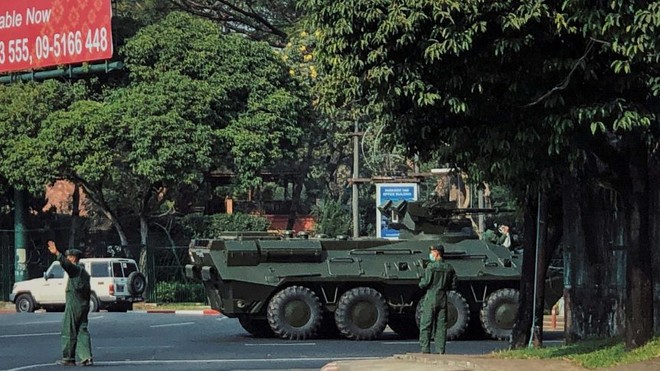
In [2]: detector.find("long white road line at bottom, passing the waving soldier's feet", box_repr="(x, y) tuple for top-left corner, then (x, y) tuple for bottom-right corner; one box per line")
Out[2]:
(6, 357), (382, 371)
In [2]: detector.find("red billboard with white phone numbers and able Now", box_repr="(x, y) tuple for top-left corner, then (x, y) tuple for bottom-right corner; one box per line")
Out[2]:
(0, 0), (112, 73)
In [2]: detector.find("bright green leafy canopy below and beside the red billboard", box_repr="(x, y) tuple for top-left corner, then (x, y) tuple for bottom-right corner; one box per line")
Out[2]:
(0, 12), (309, 248)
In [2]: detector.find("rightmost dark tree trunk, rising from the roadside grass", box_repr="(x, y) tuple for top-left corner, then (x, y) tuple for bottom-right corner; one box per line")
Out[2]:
(625, 153), (653, 350)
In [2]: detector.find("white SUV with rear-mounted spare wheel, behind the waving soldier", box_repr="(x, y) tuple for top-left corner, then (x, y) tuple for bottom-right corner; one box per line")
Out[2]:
(9, 258), (147, 312)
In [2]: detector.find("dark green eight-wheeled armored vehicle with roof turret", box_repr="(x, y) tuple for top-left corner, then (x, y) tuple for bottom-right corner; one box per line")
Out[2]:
(186, 201), (536, 340)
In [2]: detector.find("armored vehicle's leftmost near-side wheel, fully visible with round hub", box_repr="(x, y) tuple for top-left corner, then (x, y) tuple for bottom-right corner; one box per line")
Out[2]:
(267, 286), (323, 340)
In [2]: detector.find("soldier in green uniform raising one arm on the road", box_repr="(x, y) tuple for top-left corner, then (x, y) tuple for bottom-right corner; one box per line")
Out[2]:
(48, 241), (94, 366)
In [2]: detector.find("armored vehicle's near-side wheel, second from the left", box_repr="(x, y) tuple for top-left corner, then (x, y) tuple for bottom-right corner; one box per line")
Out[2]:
(335, 287), (388, 340)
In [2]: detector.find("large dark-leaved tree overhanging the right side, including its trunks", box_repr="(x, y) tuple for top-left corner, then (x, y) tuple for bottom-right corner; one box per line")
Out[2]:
(302, 0), (660, 347)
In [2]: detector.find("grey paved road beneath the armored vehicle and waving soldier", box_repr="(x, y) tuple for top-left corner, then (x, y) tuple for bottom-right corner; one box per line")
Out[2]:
(0, 312), (507, 371)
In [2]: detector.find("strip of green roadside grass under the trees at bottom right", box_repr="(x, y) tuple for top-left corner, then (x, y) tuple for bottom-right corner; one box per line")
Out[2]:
(493, 337), (660, 368)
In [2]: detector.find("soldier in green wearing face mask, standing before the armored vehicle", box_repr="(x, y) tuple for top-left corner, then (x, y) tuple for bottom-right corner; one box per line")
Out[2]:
(419, 245), (456, 354)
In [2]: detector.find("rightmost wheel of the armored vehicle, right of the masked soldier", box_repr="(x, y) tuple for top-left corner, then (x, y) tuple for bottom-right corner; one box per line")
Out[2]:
(481, 289), (520, 340)
